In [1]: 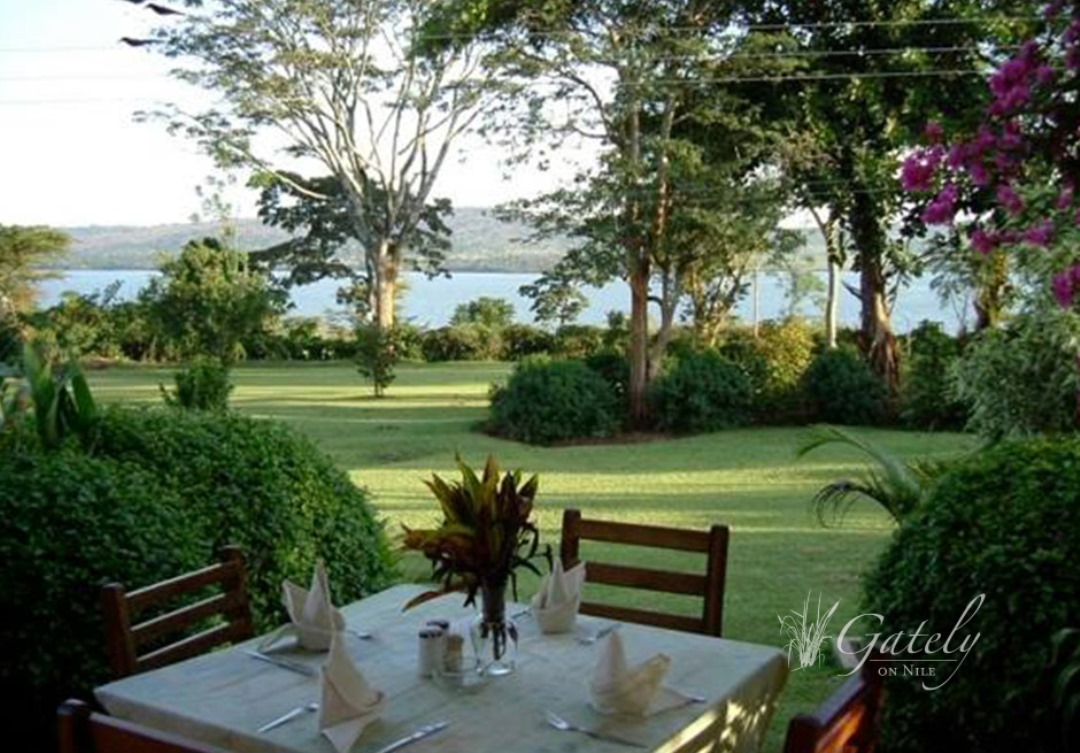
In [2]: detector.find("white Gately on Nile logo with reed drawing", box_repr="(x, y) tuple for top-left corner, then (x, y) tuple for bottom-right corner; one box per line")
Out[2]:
(778, 593), (986, 690)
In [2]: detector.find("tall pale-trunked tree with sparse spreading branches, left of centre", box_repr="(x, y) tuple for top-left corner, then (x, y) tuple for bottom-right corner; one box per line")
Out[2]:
(152, 0), (498, 327)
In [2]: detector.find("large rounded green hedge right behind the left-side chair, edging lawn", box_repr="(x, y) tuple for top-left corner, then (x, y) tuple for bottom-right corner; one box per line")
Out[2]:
(98, 409), (392, 630)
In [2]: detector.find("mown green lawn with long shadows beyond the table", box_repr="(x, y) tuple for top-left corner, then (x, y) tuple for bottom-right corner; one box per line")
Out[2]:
(91, 363), (976, 750)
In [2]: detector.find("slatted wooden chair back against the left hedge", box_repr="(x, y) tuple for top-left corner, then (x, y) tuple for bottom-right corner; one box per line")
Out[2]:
(102, 547), (254, 677)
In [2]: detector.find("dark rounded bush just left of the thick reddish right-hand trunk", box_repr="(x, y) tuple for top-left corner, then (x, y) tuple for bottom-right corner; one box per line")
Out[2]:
(802, 347), (887, 426)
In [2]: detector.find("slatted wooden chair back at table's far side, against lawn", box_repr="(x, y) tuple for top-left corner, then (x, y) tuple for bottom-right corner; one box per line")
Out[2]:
(559, 510), (730, 635)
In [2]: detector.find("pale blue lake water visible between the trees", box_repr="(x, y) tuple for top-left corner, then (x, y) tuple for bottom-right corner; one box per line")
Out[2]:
(40, 269), (960, 332)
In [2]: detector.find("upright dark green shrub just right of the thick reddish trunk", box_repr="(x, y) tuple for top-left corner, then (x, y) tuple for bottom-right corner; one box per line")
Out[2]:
(900, 322), (968, 430)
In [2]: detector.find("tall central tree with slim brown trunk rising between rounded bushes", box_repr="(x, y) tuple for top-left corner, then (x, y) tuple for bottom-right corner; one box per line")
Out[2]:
(445, 0), (794, 425)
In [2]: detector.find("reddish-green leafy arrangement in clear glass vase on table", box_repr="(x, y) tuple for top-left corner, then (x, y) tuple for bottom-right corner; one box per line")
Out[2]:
(405, 456), (551, 674)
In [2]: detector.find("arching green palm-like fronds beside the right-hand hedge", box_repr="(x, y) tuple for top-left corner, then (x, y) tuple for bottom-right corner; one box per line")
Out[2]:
(798, 426), (948, 523)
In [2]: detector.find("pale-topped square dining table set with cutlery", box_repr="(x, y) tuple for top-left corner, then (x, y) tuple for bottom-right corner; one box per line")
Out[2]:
(95, 584), (787, 753)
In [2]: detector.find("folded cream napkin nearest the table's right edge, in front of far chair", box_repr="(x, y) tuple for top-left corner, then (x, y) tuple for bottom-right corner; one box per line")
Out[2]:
(589, 631), (687, 716)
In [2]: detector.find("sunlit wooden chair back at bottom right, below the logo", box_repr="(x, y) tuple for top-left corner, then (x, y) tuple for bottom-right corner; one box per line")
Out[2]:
(784, 661), (883, 753)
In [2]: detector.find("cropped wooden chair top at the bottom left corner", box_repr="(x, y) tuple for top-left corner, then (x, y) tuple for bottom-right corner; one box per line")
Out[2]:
(57, 700), (235, 753)
